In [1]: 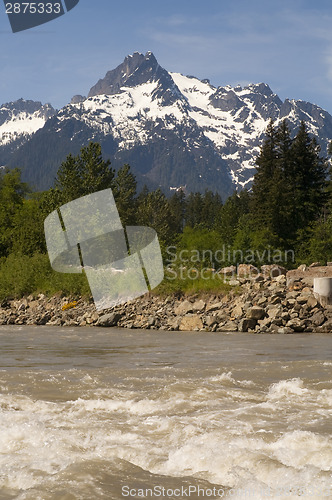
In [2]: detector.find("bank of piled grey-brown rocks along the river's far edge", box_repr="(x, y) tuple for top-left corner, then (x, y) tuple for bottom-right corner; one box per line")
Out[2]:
(0, 268), (332, 334)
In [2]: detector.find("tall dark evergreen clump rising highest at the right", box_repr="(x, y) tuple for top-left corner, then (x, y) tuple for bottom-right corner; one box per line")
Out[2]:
(252, 121), (327, 248)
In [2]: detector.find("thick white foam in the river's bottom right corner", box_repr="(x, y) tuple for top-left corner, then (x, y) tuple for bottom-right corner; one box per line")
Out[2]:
(160, 431), (332, 498)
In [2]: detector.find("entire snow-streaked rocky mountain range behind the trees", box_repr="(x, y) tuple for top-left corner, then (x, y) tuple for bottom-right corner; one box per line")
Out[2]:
(0, 52), (332, 199)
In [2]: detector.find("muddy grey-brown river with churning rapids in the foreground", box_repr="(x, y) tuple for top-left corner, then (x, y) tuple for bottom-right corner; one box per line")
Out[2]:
(0, 326), (332, 500)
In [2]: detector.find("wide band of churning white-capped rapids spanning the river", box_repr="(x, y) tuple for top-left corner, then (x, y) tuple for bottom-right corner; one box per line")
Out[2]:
(0, 369), (332, 499)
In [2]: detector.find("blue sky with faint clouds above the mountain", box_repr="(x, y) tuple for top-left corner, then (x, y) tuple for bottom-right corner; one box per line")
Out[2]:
(0, 0), (332, 113)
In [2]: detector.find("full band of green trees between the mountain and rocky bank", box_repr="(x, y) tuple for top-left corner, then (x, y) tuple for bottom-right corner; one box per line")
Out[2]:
(0, 120), (332, 292)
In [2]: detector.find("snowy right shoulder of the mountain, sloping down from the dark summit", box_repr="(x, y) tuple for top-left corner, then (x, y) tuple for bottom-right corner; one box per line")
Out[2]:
(171, 73), (332, 187)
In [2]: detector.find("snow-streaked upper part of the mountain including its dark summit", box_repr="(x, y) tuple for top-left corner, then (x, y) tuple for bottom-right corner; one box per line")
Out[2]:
(72, 52), (332, 188)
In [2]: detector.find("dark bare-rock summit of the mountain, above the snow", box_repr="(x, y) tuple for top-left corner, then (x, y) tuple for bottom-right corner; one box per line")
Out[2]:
(88, 52), (161, 97)
